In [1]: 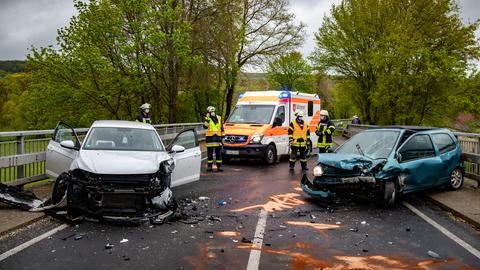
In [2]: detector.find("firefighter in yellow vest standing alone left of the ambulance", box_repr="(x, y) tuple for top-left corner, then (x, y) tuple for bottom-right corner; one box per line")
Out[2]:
(203, 106), (224, 172)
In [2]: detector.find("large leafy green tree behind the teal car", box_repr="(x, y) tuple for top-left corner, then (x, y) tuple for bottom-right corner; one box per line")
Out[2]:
(313, 0), (478, 125)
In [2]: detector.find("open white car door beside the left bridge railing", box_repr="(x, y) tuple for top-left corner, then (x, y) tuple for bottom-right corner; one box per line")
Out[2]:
(46, 122), (80, 178)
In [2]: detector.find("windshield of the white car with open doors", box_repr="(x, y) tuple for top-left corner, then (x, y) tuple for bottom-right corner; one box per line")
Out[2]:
(83, 127), (164, 151)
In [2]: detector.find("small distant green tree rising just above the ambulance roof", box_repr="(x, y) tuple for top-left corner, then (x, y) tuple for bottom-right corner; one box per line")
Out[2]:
(268, 52), (314, 93)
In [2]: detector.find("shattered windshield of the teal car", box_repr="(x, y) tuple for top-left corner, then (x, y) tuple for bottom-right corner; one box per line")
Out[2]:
(336, 130), (400, 159)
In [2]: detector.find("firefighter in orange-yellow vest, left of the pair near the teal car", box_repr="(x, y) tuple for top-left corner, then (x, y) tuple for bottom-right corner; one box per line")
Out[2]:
(288, 111), (310, 171)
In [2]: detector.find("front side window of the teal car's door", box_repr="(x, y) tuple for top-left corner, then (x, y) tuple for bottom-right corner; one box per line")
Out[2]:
(399, 135), (435, 162)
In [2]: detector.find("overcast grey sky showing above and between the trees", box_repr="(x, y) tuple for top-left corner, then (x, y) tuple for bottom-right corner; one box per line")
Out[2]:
(0, 0), (480, 60)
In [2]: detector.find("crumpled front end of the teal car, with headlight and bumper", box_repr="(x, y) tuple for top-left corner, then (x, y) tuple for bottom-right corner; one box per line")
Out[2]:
(300, 153), (399, 198)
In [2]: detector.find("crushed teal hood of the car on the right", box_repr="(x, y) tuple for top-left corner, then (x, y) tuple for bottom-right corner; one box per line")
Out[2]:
(318, 153), (374, 171)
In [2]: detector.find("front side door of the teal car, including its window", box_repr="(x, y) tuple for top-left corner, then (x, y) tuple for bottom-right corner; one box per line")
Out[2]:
(397, 134), (442, 192)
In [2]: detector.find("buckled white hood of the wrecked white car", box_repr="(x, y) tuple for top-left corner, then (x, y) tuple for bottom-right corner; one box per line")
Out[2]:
(71, 150), (170, 174)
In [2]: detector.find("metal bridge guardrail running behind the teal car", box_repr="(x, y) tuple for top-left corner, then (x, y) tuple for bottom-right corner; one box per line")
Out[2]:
(343, 124), (480, 186)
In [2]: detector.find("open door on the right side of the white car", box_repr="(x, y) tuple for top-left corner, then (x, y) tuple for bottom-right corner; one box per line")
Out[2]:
(167, 129), (202, 187)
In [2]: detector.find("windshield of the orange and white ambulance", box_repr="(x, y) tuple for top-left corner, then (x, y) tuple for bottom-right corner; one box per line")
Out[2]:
(227, 105), (275, 124)
